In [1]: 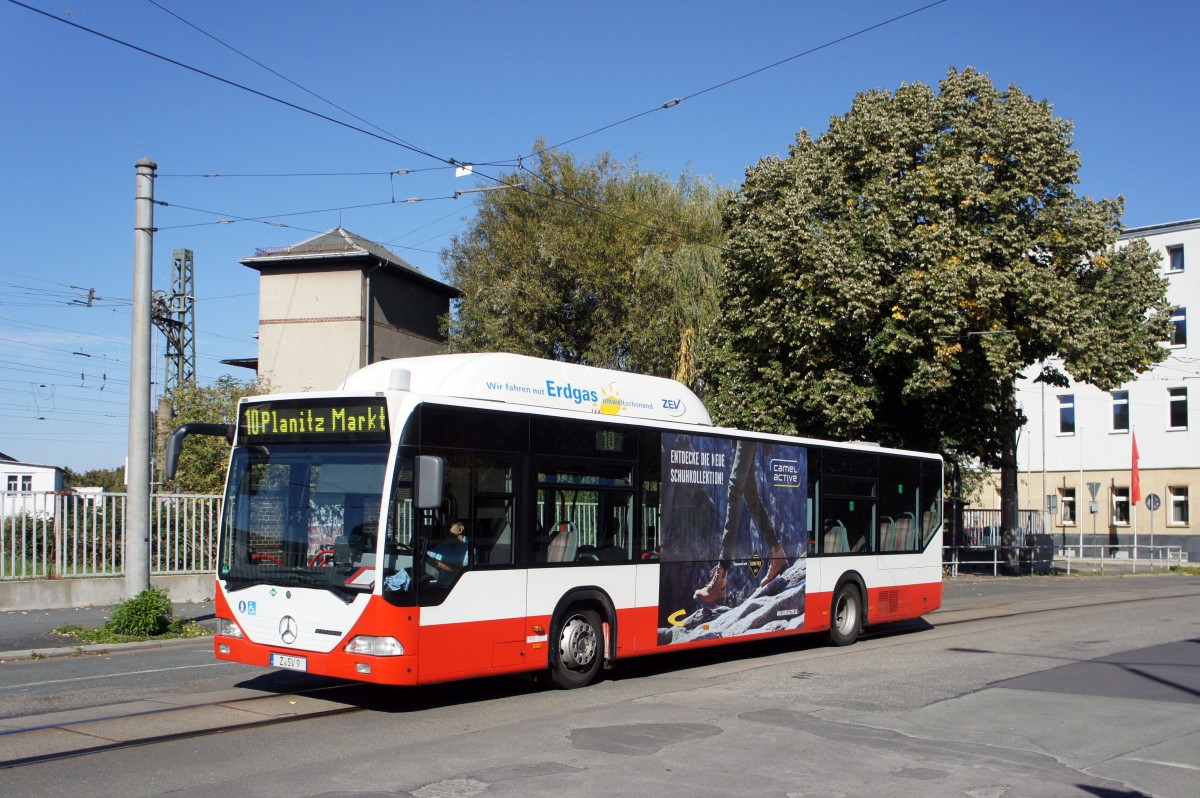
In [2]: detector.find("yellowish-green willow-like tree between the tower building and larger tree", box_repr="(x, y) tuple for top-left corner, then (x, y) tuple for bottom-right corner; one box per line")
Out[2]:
(443, 142), (728, 391)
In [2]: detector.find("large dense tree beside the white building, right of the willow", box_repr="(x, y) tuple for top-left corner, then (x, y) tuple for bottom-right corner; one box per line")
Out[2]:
(707, 70), (1170, 528)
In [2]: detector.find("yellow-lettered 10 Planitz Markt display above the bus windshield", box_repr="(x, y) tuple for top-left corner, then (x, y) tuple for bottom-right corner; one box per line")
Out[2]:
(238, 397), (388, 443)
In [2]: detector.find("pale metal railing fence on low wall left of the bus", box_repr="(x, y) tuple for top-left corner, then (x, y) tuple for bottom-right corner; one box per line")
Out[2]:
(0, 491), (221, 580)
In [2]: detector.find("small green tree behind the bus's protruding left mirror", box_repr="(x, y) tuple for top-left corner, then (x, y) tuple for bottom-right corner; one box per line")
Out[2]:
(157, 376), (270, 493)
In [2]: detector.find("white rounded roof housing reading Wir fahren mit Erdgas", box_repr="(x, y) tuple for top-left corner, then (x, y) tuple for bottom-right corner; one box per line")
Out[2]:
(342, 353), (713, 426)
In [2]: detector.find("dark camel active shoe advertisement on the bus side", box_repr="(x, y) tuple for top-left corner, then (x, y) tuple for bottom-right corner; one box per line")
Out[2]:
(659, 433), (809, 646)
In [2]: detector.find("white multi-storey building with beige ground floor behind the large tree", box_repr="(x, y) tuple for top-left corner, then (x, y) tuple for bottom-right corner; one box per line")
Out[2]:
(978, 218), (1200, 562)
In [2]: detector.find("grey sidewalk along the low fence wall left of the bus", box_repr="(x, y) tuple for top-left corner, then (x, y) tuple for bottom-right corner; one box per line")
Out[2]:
(0, 601), (214, 661)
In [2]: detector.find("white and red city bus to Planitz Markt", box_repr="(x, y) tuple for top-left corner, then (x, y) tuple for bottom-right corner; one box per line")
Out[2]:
(168, 354), (942, 688)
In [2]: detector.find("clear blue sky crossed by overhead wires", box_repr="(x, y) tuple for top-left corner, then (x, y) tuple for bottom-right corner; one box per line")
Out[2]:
(0, 0), (1200, 470)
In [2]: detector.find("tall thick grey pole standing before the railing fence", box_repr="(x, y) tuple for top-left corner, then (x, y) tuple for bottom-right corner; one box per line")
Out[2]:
(125, 158), (158, 598)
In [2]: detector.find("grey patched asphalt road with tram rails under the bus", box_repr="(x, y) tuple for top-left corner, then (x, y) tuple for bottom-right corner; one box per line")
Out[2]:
(0, 576), (1200, 798)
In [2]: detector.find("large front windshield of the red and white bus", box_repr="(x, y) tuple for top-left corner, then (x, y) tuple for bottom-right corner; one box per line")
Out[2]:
(218, 443), (388, 600)
